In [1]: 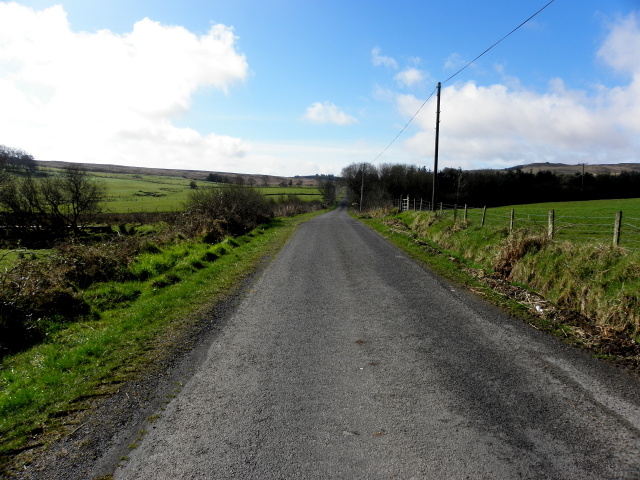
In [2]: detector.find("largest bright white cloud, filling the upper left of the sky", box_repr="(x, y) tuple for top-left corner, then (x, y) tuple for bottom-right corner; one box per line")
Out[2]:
(0, 2), (249, 169)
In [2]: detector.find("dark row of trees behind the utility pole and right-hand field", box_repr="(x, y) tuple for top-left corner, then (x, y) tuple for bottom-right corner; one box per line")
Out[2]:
(342, 163), (640, 208)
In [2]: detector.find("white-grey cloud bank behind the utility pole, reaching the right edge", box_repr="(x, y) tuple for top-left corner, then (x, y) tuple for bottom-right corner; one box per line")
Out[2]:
(396, 15), (640, 168)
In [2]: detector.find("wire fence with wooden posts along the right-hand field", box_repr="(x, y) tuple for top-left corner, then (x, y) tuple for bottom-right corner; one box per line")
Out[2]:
(394, 197), (640, 250)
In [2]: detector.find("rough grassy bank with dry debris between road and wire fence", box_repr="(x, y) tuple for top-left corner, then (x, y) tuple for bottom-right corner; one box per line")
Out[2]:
(361, 207), (640, 373)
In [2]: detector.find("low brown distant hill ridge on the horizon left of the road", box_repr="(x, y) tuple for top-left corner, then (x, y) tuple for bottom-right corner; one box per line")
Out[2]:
(36, 160), (316, 185)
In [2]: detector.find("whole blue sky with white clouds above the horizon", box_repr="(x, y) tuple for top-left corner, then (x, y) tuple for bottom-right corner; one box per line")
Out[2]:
(0, 0), (640, 176)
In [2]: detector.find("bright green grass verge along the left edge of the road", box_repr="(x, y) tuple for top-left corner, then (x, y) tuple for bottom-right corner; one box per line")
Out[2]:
(0, 210), (320, 461)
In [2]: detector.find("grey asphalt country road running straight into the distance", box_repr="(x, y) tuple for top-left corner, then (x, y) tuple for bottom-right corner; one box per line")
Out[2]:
(114, 203), (640, 480)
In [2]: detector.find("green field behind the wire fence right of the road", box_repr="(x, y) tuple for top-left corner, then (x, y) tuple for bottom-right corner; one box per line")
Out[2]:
(447, 198), (640, 248)
